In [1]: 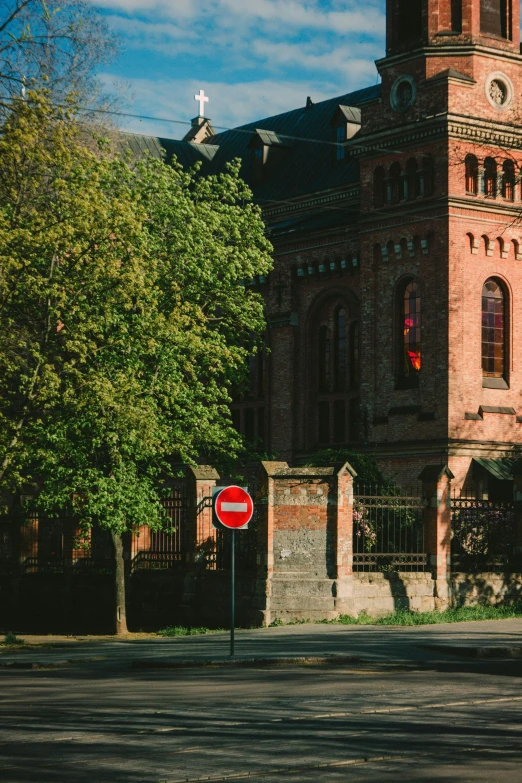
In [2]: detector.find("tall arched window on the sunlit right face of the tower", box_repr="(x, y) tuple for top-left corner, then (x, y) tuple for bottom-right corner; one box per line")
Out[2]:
(482, 279), (506, 378)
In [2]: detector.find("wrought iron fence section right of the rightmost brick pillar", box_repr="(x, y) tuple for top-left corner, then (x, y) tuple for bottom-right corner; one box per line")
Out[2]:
(451, 491), (518, 571)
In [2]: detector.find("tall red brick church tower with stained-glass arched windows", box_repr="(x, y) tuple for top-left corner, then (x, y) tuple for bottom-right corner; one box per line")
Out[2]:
(352, 0), (522, 485)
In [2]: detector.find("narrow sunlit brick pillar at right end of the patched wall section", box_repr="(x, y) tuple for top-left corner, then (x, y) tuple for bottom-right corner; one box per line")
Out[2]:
(335, 462), (357, 615)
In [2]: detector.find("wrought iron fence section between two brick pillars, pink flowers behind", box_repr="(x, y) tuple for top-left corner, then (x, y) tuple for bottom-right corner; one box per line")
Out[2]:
(353, 484), (428, 572)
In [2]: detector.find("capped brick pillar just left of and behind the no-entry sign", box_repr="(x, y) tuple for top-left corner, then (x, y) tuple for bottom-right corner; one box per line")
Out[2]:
(184, 465), (220, 559)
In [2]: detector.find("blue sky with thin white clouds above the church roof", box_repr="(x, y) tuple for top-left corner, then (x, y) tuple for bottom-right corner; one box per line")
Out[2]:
(91, 0), (385, 138)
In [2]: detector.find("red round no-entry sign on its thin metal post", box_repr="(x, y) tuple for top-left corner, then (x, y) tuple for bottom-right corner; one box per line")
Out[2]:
(212, 485), (254, 658)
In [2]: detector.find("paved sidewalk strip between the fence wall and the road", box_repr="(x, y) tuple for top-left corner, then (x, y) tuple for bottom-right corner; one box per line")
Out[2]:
(0, 618), (522, 667)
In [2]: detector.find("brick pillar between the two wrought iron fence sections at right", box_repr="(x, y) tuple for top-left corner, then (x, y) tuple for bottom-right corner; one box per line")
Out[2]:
(419, 465), (453, 609)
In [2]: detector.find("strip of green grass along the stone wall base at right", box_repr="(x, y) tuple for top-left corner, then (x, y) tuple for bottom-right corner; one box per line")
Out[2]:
(327, 603), (522, 625)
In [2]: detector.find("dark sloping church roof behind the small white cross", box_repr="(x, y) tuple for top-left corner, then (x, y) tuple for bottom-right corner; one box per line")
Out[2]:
(117, 85), (381, 217)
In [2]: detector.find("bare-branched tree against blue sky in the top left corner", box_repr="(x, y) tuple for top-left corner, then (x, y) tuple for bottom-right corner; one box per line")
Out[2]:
(0, 0), (115, 108)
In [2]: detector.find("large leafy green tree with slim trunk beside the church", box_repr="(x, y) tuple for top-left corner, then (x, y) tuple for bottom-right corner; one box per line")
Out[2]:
(0, 95), (271, 632)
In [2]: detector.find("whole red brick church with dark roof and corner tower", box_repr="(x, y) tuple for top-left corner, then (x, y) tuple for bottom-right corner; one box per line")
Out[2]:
(127, 0), (522, 495)
